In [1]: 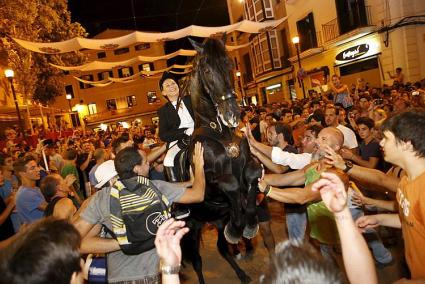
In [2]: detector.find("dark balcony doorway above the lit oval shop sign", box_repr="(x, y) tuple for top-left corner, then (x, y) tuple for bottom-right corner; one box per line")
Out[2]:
(335, 0), (367, 34)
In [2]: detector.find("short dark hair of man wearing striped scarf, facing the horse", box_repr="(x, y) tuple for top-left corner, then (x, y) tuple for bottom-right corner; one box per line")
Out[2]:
(114, 147), (143, 179)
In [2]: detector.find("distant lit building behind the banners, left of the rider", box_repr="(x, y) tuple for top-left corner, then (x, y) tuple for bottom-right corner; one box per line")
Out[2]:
(54, 29), (167, 128)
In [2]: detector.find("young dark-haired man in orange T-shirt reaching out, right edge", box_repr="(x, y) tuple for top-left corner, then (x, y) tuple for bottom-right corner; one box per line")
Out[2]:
(327, 109), (425, 283)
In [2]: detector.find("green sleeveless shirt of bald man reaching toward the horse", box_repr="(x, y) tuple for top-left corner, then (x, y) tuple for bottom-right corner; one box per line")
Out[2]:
(305, 167), (339, 245)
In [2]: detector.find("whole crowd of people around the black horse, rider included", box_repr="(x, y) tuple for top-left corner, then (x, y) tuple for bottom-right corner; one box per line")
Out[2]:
(0, 70), (425, 283)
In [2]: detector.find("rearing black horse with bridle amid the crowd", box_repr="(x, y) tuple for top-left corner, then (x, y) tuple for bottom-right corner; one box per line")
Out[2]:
(177, 36), (262, 283)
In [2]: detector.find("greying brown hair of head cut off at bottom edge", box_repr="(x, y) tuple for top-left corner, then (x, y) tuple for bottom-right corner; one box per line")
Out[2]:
(260, 240), (344, 284)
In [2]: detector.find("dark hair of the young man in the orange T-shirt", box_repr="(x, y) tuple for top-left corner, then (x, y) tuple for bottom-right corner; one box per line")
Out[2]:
(382, 108), (425, 158)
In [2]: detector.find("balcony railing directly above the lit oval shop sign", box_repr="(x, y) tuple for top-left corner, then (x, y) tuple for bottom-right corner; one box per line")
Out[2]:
(322, 6), (372, 43)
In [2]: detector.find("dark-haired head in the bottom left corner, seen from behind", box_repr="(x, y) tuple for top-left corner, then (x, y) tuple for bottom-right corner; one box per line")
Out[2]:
(0, 217), (81, 284)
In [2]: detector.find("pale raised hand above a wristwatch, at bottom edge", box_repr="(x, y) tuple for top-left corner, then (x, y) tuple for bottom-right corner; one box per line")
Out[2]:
(155, 219), (189, 266)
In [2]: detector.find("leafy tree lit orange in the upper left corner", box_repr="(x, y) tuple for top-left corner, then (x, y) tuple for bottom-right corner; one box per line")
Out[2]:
(0, 0), (87, 104)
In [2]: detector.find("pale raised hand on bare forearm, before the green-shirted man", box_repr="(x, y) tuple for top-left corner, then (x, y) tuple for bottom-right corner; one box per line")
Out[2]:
(311, 173), (347, 213)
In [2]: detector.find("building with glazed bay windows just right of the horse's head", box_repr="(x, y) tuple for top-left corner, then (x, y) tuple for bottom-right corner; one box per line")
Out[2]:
(227, 0), (294, 105)
